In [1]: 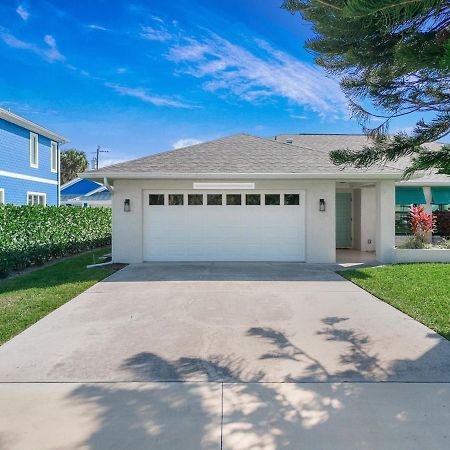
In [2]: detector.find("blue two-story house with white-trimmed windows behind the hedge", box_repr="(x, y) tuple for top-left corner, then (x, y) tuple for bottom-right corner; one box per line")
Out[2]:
(0, 108), (67, 206)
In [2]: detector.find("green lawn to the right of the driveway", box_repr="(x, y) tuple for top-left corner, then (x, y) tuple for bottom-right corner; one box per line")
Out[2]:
(339, 264), (450, 340)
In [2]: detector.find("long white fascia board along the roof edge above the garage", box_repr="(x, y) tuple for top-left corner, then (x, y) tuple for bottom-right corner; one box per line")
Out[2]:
(79, 172), (402, 181)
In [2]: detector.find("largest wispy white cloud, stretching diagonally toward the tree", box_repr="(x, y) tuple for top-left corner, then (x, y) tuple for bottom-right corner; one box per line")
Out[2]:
(167, 33), (347, 118)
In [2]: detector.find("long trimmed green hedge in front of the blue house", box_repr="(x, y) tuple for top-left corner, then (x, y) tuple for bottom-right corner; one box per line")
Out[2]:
(0, 205), (111, 277)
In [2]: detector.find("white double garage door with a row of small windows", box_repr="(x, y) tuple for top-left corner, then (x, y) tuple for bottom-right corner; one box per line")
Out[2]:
(143, 191), (305, 261)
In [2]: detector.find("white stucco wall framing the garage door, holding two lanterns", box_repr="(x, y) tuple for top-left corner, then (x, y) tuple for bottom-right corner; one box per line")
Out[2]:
(112, 179), (336, 263)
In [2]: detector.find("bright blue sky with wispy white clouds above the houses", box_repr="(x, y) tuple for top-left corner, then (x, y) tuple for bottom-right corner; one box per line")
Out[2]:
(0, 0), (438, 164)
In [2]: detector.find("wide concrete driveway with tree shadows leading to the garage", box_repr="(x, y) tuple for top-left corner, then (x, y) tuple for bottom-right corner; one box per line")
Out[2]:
(0, 263), (450, 450)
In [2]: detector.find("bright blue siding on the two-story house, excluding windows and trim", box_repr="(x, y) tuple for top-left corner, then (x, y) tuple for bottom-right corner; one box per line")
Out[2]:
(0, 119), (58, 205)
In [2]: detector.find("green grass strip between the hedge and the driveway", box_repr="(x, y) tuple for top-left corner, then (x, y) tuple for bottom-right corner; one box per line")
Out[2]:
(0, 248), (118, 344)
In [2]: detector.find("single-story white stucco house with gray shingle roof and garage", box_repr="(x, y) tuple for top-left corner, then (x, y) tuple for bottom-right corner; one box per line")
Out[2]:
(80, 134), (450, 263)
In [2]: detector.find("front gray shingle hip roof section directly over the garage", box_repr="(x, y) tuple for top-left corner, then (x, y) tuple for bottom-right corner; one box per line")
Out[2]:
(87, 134), (399, 177)
